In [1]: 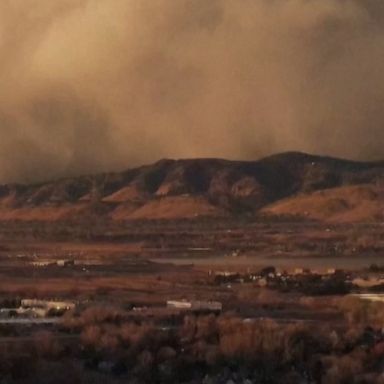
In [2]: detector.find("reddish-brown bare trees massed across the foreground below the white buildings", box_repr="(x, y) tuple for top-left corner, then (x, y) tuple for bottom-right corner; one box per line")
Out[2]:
(0, 299), (384, 384)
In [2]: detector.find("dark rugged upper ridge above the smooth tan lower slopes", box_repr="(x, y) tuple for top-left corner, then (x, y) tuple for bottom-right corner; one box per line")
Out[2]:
(0, 152), (384, 220)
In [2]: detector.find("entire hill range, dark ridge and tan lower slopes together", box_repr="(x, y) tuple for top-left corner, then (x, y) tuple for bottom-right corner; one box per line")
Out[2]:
(0, 152), (384, 221)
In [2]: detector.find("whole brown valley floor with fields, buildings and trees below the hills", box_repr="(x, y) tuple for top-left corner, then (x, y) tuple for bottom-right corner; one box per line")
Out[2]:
(0, 220), (384, 383)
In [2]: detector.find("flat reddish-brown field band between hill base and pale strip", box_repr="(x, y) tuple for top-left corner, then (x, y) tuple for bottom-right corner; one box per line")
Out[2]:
(0, 219), (384, 263)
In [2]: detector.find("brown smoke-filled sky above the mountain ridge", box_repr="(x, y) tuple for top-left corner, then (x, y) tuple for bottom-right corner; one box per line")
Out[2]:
(0, 0), (384, 181)
